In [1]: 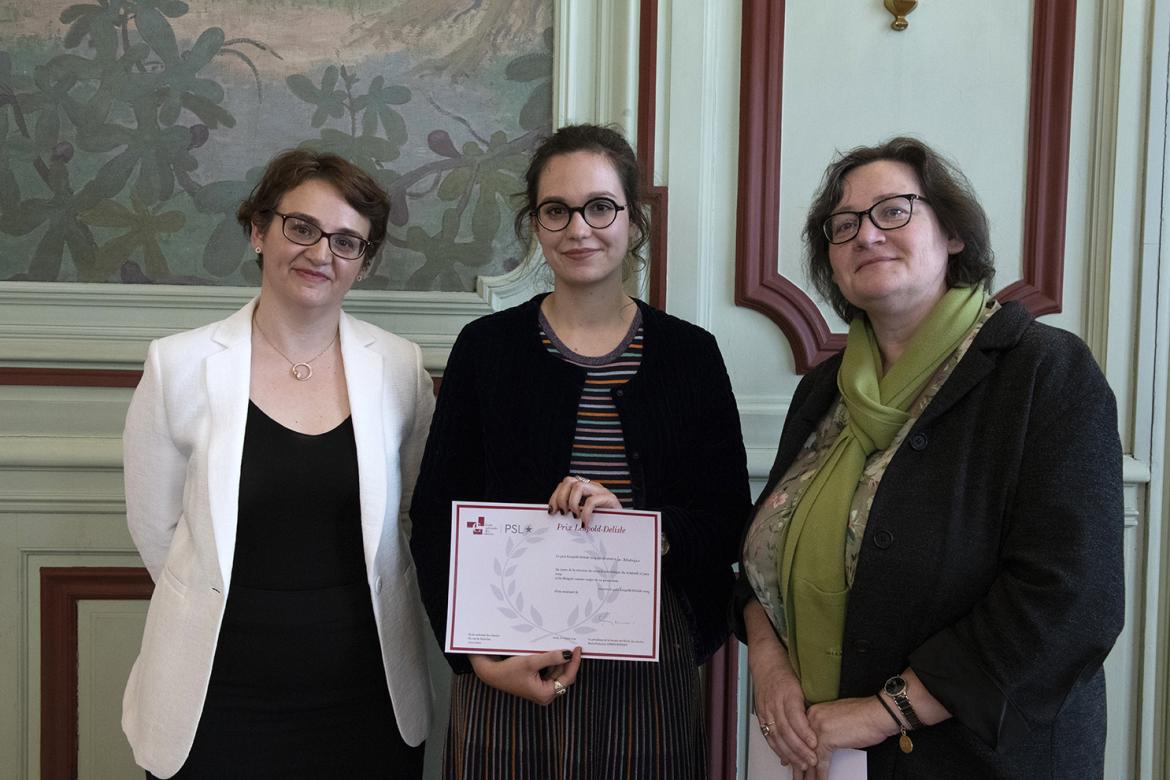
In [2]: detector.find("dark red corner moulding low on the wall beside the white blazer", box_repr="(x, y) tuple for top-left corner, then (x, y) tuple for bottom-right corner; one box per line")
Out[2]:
(41, 566), (154, 780)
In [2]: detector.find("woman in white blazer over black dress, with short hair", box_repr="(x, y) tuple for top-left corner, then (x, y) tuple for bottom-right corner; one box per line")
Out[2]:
(122, 150), (434, 778)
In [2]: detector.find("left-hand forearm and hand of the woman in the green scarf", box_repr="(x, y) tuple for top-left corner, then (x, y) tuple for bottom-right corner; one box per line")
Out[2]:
(744, 599), (817, 771)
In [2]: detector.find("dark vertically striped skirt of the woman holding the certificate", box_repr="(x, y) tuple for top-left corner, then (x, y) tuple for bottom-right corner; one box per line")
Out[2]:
(443, 584), (707, 780)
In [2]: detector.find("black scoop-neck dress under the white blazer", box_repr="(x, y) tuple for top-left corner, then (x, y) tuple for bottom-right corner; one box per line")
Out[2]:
(161, 402), (422, 779)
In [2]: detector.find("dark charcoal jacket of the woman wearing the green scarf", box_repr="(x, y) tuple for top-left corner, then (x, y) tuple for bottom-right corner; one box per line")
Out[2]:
(737, 303), (1124, 780)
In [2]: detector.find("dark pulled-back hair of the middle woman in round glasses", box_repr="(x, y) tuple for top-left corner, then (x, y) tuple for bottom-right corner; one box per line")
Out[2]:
(512, 125), (651, 271)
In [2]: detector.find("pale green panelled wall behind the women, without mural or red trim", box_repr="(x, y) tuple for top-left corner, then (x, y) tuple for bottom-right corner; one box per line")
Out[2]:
(0, 0), (1170, 778)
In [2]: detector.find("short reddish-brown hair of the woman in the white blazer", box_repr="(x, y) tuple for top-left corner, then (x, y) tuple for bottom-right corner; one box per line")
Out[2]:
(235, 149), (390, 268)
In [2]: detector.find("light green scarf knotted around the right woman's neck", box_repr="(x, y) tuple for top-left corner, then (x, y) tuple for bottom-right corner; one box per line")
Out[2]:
(777, 287), (987, 704)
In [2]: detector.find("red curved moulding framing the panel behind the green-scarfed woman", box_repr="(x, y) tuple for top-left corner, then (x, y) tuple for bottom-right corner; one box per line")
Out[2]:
(735, 0), (1076, 373)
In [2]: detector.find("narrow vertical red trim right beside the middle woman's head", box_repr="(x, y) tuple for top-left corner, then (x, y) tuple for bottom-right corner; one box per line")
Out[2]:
(635, 0), (669, 311)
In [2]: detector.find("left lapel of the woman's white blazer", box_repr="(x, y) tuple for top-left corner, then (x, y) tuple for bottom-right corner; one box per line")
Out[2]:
(204, 298), (256, 593)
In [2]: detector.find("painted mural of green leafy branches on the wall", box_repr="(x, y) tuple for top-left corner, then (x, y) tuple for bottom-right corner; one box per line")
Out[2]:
(0, 0), (552, 291)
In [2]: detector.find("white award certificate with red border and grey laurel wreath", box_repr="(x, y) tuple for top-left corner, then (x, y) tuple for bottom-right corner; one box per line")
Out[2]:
(445, 501), (662, 661)
